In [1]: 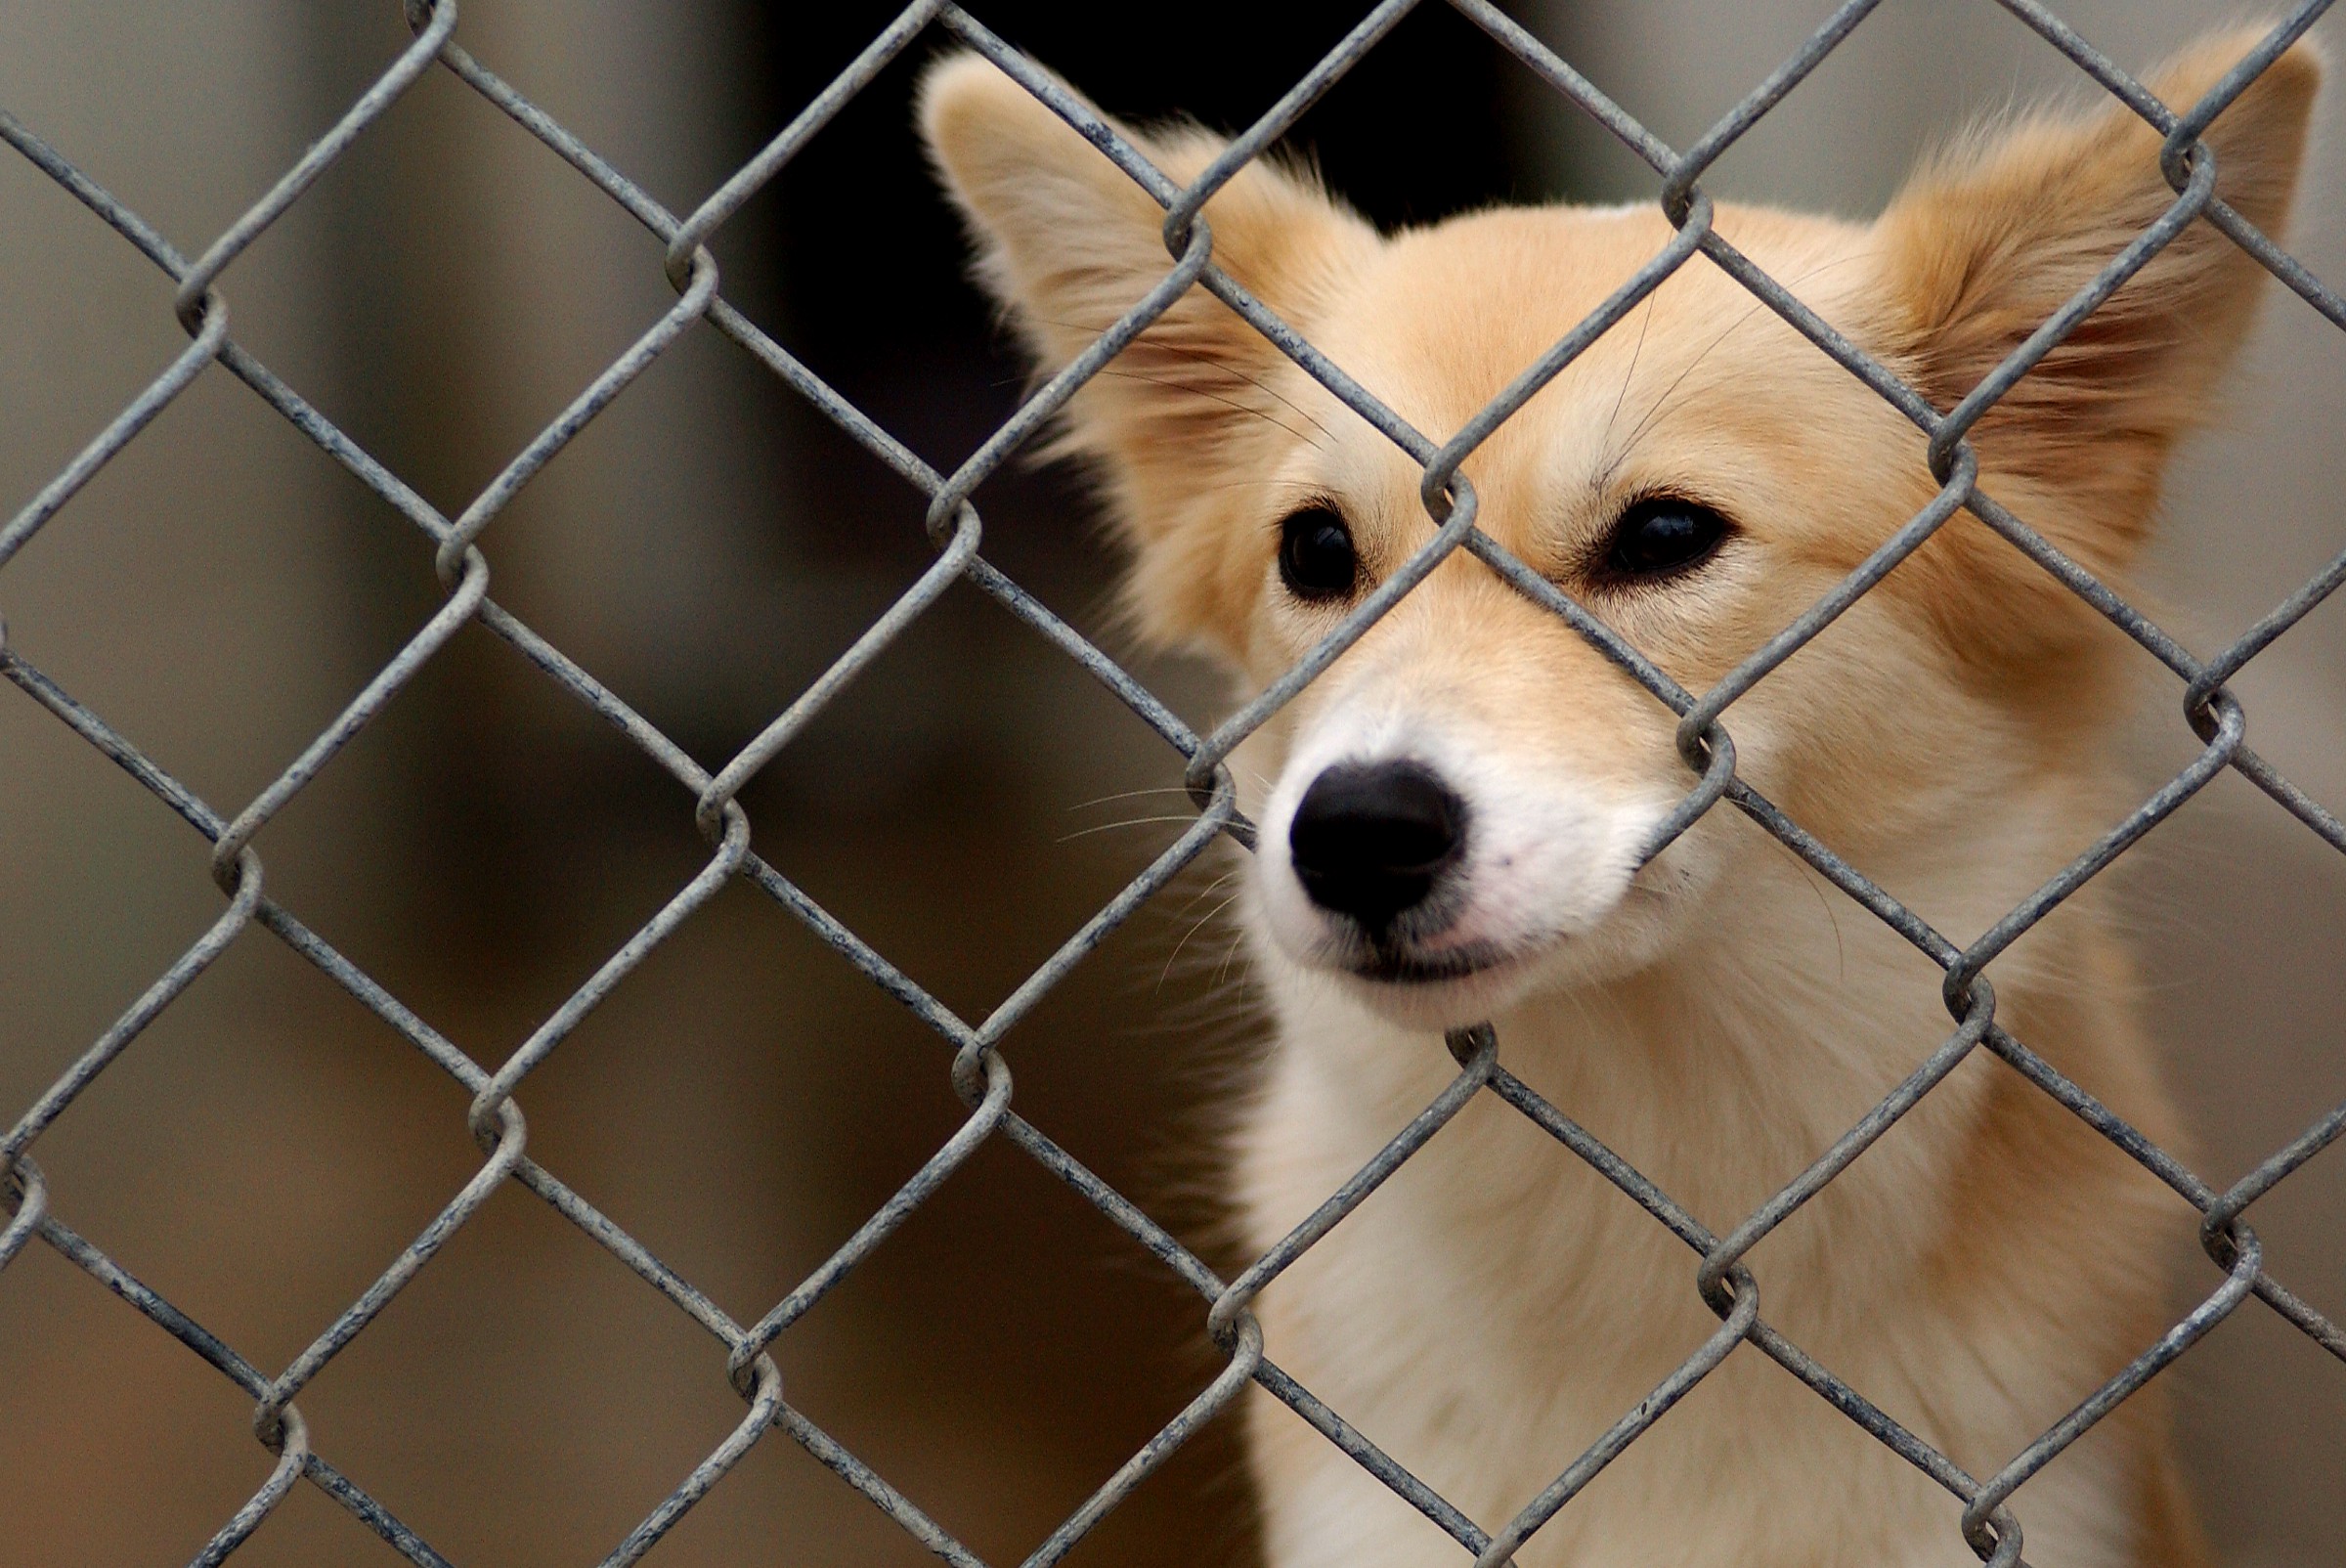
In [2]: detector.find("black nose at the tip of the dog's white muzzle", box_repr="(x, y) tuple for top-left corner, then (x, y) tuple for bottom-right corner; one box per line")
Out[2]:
(1288, 761), (1466, 932)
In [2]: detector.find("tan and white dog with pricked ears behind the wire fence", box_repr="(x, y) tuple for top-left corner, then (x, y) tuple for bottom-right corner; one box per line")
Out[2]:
(917, 33), (2323, 1568)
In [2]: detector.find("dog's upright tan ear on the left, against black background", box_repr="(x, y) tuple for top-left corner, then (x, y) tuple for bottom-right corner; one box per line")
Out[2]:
(920, 54), (1377, 641)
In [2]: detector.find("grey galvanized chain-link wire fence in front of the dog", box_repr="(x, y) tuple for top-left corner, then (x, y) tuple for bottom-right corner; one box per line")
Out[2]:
(0, 0), (2346, 1568)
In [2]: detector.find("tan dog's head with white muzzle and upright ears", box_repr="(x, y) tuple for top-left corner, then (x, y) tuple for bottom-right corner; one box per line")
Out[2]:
(922, 37), (2321, 1024)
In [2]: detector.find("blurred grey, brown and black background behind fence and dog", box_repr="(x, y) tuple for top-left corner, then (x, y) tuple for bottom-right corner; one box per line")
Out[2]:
(0, 0), (2346, 1568)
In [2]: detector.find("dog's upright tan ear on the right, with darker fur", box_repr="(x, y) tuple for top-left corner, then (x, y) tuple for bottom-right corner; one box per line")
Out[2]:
(1875, 33), (2323, 570)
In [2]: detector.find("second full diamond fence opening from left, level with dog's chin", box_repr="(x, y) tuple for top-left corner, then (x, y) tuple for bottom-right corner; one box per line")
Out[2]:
(513, 868), (969, 1295)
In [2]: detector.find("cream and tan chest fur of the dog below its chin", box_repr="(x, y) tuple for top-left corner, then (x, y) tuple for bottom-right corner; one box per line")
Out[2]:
(1238, 887), (2151, 1568)
